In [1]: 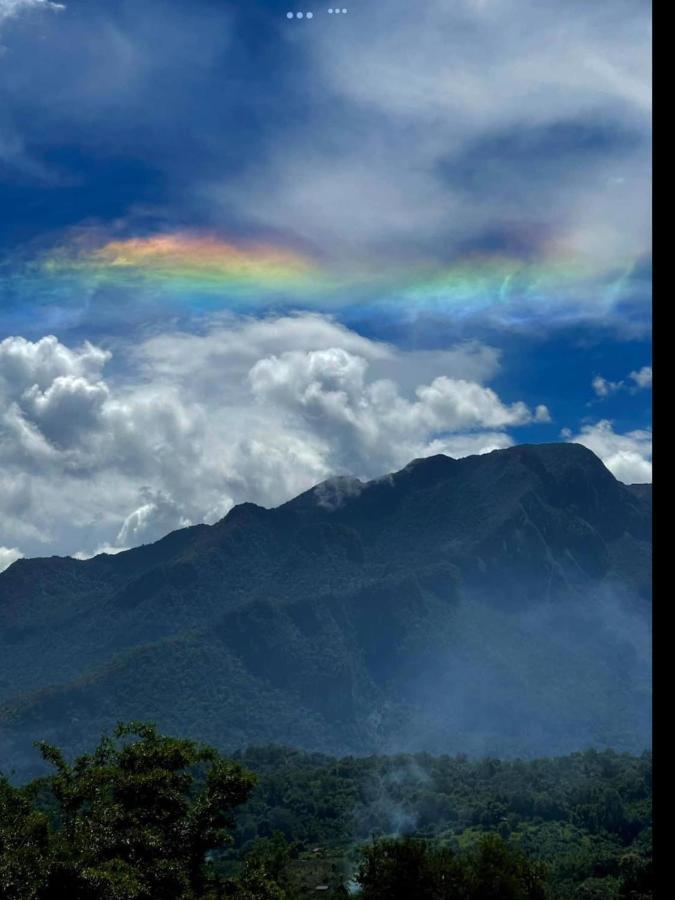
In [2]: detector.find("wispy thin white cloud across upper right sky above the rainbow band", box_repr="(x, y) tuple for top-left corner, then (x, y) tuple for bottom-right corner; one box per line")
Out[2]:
(213, 0), (651, 315)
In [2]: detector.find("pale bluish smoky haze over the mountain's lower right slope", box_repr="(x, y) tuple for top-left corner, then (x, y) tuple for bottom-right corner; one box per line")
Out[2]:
(381, 586), (652, 758)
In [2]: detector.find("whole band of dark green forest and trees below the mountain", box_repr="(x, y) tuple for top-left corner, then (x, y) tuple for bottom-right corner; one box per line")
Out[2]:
(0, 724), (652, 900)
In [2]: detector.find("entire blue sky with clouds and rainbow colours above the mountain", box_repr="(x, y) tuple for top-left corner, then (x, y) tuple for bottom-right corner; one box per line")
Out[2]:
(0, 0), (652, 570)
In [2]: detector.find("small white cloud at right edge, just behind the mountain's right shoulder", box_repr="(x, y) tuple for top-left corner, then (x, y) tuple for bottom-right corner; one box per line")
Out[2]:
(563, 419), (652, 484)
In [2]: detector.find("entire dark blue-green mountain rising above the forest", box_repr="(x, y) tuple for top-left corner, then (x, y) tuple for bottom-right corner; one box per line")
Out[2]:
(0, 444), (651, 770)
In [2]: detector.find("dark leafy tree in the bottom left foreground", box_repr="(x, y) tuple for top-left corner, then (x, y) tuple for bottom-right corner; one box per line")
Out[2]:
(0, 723), (254, 900)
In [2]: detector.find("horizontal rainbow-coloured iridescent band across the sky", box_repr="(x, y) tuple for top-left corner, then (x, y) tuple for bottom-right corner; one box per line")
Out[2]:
(0, 232), (648, 330)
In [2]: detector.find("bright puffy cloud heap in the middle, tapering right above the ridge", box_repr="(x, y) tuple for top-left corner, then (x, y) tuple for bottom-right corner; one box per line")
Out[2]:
(248, 347), (548, 474)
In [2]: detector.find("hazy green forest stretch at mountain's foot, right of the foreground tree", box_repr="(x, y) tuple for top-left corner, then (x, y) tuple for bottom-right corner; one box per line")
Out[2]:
(232, 747), (651, 900)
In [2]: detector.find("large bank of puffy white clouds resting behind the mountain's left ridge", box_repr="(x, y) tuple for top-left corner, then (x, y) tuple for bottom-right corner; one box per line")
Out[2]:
(0, 315), (548, 556)
